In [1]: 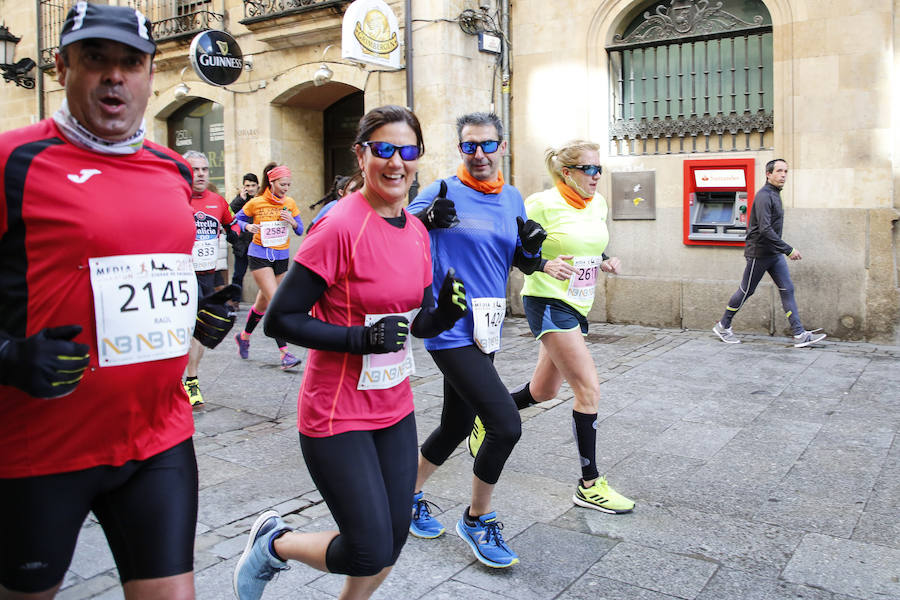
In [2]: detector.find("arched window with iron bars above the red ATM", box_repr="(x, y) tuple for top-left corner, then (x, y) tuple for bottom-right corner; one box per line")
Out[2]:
(606, 0), (774, 155)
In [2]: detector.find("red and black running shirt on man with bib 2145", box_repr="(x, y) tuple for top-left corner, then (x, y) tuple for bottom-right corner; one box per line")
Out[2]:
(0, 119), (195, 478)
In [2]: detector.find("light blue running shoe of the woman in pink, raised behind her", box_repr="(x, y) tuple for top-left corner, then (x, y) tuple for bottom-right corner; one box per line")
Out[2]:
(232, 510), (290, 600)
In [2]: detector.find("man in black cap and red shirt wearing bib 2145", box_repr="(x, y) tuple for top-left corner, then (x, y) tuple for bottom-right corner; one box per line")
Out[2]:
(0, 2), (198, 600)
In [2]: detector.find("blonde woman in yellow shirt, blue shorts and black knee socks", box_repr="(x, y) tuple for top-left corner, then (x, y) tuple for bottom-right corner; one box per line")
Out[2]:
(469, 140), (634, 514)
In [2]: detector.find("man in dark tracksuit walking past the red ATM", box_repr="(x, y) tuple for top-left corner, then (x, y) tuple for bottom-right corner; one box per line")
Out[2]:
(713, 158), (825, 348)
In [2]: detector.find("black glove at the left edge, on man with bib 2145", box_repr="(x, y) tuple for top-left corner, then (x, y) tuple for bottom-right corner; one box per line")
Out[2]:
(0, 325), (91, 398)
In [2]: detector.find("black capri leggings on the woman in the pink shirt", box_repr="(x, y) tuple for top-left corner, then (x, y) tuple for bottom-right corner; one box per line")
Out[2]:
(300, 413), (418, 577)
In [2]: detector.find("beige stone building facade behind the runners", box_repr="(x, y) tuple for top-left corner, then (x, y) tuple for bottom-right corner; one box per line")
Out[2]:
(0, 0), (900, 343)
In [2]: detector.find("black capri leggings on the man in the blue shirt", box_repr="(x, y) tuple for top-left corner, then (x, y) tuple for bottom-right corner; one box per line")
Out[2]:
(422, 346), (522, 484)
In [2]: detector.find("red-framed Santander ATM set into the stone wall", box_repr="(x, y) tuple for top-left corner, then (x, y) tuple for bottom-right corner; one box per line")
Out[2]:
(684, 158), (755, 246)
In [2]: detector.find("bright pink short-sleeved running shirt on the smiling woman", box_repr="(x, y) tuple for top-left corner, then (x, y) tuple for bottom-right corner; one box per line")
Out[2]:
(294, 192), (431, 437)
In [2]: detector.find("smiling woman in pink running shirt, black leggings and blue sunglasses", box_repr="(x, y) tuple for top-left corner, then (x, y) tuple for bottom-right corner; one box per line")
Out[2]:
(234, 106), (466, 600)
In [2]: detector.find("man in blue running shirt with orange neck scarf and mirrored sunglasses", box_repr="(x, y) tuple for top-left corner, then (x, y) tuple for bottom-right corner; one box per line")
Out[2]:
(409, 113), (546, 568)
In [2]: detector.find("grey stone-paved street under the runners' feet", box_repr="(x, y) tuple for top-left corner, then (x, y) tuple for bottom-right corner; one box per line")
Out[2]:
(59, 314), (900, 600)
